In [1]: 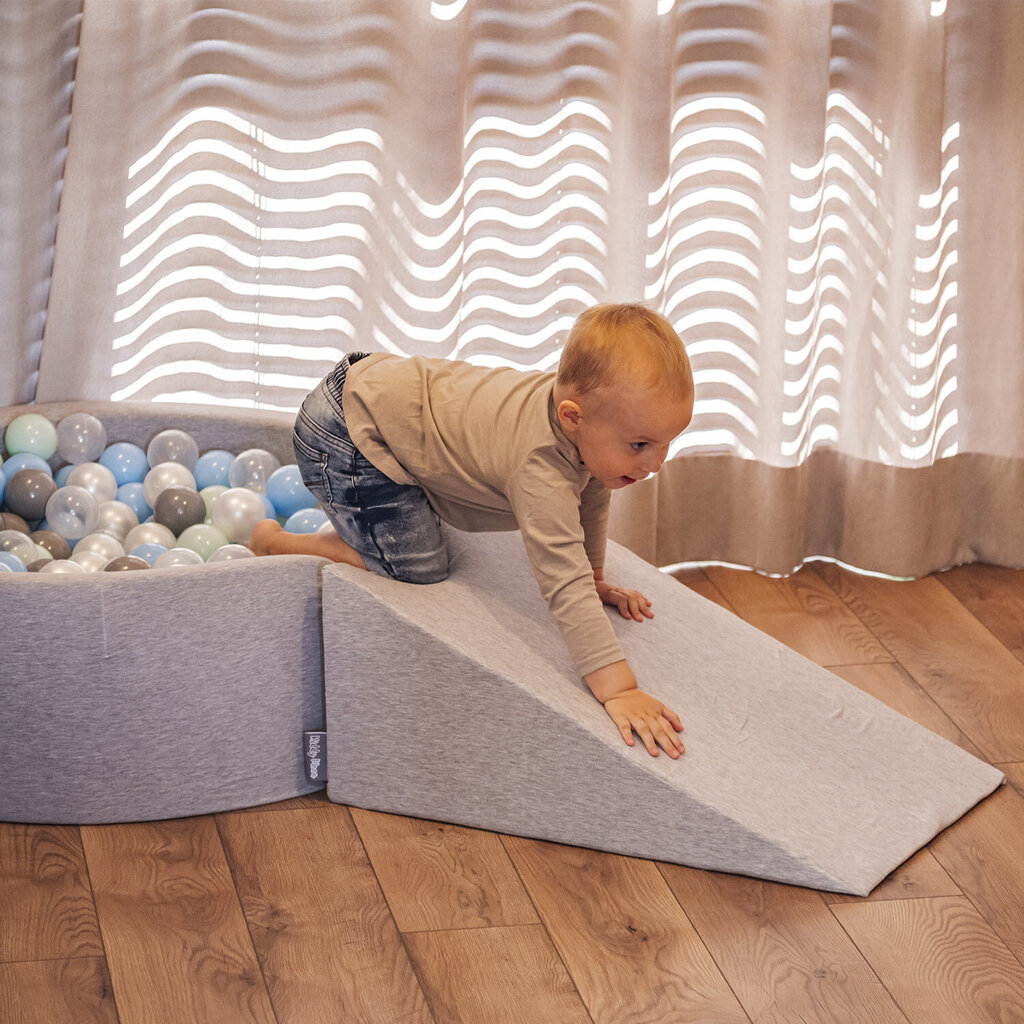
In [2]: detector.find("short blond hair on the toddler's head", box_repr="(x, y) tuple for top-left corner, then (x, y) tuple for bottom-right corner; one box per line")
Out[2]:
(558, 303), (693, 395)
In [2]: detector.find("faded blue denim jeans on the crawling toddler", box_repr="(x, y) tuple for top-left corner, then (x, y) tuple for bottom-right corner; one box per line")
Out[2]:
(292, 354), (449, 583)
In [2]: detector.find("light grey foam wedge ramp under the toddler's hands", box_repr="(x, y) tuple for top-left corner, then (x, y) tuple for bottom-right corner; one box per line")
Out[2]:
(323, 534), (1002, 895)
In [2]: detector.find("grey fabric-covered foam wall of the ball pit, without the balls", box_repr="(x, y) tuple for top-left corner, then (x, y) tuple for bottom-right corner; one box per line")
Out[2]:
(0, 401), (325, 824)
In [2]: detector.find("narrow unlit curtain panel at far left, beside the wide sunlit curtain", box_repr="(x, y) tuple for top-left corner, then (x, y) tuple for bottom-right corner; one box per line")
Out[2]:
(0, 0), (82, 404)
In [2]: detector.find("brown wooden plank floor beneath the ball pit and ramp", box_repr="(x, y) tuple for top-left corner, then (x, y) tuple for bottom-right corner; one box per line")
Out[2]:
(0, 564), (1024, 1024)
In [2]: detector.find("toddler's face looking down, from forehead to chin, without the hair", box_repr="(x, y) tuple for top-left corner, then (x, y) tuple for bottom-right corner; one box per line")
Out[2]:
(558, 386), (693, 489)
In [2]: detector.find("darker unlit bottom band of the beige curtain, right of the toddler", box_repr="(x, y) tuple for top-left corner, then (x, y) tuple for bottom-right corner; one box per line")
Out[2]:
(610, 450), (1024, 578)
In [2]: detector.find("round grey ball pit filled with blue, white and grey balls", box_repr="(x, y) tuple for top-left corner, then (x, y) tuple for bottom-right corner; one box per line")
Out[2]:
(0, 401), (325, 824)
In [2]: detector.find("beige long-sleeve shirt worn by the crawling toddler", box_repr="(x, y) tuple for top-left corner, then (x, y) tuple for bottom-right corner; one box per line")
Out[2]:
(342, 352), (624, 676)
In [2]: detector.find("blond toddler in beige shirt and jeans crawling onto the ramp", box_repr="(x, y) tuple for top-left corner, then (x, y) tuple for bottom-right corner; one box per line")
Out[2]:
(252, 304), (693, 758)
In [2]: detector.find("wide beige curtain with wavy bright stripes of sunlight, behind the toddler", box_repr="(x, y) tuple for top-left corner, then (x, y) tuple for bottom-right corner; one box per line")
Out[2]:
(18, 0), (1024, 574)
